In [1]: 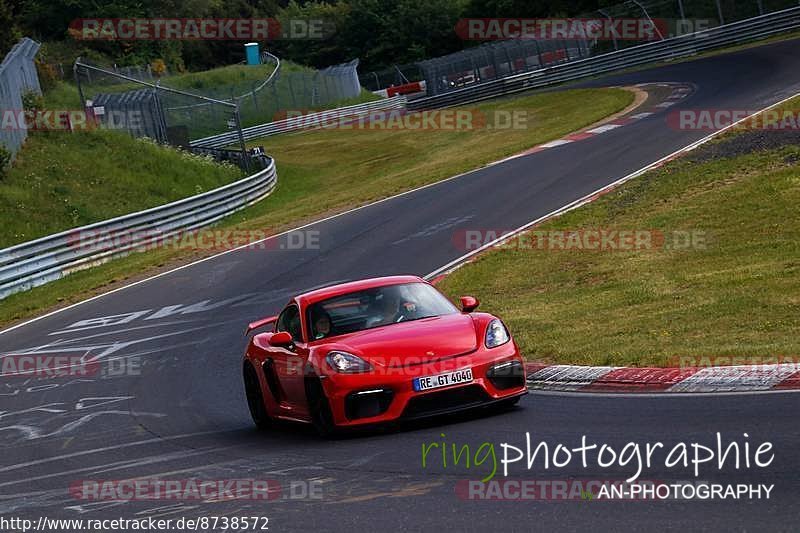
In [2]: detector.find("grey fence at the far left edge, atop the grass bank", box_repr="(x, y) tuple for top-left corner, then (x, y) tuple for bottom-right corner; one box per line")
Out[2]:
(0, 37), (42, 159)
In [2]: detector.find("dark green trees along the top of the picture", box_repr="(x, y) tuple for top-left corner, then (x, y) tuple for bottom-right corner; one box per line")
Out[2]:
(0, 0), (613, 72)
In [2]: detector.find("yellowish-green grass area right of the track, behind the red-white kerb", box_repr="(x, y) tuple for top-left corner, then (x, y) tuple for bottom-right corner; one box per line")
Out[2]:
(441, 139), (800, 366)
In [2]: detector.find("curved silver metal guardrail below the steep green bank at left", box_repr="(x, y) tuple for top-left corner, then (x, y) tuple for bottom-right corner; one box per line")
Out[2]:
(0, 156), (278, 299)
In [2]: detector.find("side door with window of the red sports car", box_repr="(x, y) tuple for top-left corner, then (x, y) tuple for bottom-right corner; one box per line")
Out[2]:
(265, 303), (308, 417)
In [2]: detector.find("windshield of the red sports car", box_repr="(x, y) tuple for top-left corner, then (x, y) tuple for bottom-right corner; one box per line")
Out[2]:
(307, 283), (458, 341)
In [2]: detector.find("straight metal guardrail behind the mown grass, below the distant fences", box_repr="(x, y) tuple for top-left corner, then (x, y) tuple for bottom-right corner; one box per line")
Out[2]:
(189, 95), (407, 148)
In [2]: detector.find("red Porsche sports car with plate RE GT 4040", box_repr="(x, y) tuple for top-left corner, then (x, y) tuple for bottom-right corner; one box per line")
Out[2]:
(243, 276), (527, 434)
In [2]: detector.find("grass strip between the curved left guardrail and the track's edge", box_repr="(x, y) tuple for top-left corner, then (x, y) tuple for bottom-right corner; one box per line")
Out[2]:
(0, 89), (633, 324)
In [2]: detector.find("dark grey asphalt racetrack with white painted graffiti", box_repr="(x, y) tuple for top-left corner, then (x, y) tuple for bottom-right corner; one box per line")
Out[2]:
(0, 41), (800, 531)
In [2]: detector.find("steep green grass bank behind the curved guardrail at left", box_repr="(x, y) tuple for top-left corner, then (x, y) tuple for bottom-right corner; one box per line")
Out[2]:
(0, 130), (241, 248)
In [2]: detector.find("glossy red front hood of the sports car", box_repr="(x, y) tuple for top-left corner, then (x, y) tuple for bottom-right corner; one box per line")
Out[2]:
(324, 313), (478, 367)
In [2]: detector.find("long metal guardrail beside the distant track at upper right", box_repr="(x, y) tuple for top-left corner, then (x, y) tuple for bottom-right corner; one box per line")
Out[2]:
(408, 7), (800, 111)
